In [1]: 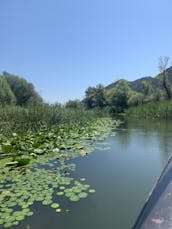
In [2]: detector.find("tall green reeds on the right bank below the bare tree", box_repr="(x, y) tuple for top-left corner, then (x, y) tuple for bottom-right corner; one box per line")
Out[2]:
(125, 101), (172, 119)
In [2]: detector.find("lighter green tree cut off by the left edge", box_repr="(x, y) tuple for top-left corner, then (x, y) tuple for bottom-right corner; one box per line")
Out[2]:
(0, 77), (16, 106)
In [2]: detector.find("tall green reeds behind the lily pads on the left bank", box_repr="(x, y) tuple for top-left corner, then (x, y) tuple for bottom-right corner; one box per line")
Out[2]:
(0, 105), (105, 134)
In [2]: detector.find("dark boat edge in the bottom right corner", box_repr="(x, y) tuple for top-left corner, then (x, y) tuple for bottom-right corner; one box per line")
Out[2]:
(133, 157), (172, 229)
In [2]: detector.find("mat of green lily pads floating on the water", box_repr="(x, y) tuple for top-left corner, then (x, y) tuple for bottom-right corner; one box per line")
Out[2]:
(0, 119), (119, 228)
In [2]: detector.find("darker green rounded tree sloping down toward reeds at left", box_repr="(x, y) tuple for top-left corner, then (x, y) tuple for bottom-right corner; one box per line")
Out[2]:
(2, 72), (43, 106)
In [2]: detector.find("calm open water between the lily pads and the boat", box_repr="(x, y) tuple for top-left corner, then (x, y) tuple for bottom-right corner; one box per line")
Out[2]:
(7, 121), (172, 229)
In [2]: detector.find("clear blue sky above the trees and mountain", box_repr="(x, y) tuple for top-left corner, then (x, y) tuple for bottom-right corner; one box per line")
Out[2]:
(0, 0), (172, 102)
